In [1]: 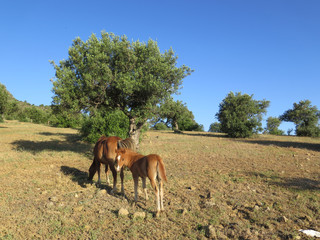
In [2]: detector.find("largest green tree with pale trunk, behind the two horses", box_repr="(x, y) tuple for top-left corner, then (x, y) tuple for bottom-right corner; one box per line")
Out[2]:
(52, 32), (192, 144)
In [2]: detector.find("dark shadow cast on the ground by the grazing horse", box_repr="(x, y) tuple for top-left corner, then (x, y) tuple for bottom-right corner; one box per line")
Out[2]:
(60, 166), (112, 192)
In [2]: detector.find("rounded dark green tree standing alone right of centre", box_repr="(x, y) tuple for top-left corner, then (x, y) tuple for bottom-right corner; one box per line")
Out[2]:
(216, 92), (270, 138)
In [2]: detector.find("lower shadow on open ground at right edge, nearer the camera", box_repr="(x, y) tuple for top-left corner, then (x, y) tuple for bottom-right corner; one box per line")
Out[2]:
(246, 172), (320, 191)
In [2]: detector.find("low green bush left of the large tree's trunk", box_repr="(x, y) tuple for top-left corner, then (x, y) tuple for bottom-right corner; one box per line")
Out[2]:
(80, 111), (129, 143)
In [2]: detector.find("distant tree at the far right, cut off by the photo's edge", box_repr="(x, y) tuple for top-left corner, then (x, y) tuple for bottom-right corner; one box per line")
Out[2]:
(279, 100), (320, 137)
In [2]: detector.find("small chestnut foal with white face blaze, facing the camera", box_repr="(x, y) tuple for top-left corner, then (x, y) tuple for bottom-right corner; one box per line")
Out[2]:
(115, 149), (167, 216)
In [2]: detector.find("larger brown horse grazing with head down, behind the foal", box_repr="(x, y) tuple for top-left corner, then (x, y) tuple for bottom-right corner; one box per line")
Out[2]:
(88, 136), (134, 194)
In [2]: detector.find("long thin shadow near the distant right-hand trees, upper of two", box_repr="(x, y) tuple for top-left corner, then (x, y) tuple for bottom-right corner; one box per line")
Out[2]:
(237, 139), (320, 152)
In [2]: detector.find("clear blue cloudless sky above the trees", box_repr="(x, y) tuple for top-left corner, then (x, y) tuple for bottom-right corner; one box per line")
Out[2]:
(0, 0), (320, 130)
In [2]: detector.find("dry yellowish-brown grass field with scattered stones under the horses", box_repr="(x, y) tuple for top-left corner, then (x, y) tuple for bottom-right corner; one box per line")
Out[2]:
(0, 121), (320, 239)
